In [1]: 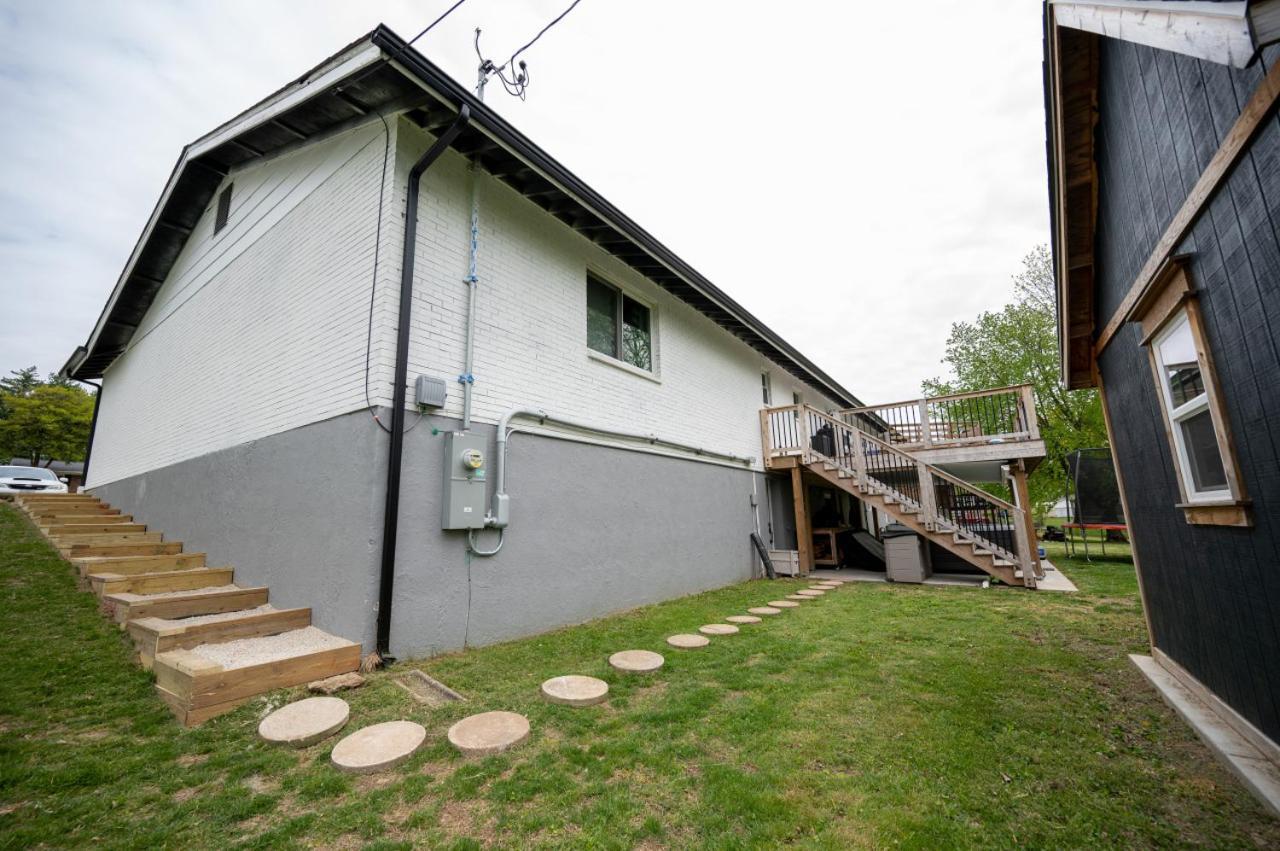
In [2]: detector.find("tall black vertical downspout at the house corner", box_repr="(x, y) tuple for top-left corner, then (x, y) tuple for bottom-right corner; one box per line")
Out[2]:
(378, 104), (471, 664)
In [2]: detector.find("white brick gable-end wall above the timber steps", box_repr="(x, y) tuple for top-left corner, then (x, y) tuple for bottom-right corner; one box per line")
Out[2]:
(90, 123), (401, 485)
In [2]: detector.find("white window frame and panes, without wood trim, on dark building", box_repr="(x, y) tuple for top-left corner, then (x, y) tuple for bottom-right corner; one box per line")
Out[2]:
(1152, 307), (1231, 503)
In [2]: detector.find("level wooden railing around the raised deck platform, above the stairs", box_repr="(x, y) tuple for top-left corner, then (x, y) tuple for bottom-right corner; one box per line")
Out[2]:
(836, 384), (1039, 449)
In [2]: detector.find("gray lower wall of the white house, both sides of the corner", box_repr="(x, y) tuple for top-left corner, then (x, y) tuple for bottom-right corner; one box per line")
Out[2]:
(93, 412), (767, 658)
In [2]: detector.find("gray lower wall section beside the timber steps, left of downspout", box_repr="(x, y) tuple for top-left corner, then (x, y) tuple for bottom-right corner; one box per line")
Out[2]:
(92, 412), (387, 650)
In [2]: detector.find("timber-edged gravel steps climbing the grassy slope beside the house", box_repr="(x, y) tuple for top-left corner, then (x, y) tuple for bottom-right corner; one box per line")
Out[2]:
(15, 494), (360, 726)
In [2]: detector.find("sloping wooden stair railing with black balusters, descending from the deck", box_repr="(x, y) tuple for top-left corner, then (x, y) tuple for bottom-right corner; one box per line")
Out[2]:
(760, 404), (1037, 586)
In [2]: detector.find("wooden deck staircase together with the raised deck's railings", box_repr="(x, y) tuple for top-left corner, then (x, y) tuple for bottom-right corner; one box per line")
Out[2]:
(760, 388), (1043, 589)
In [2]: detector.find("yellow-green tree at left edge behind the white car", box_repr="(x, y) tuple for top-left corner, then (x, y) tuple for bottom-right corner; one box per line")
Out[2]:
(0, 366), (93, 463)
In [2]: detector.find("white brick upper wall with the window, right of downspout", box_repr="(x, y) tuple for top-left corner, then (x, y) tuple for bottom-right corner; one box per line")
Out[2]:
(394, 124), (840, 465)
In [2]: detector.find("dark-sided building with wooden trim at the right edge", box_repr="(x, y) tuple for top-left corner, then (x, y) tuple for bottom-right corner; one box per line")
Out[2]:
(1046, 3), (1280, 805)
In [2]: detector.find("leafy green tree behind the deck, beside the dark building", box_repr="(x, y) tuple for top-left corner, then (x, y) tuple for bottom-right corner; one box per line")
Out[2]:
(923, 246), (1107, 513)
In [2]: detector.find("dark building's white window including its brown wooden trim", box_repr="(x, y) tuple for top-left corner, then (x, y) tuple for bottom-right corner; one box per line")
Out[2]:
(1132, 262), (1252, 526)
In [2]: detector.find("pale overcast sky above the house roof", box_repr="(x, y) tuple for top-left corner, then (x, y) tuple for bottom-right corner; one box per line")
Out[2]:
(0, 0), (1048, 403)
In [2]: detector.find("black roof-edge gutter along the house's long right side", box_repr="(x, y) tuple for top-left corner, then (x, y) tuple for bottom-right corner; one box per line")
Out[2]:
(370, 24), (863, 408)
